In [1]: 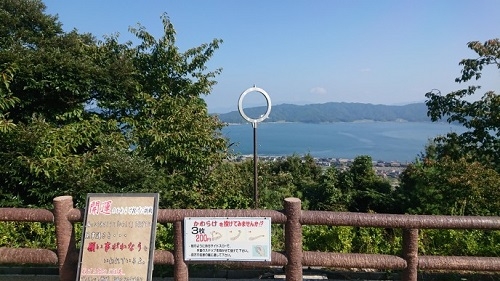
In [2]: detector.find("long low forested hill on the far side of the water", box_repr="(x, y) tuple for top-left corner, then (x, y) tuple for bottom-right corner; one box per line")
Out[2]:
(218, 102), (430, 123)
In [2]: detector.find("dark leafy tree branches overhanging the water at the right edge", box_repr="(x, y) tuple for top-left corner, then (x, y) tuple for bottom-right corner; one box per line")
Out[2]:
(426, 39), (500, 167)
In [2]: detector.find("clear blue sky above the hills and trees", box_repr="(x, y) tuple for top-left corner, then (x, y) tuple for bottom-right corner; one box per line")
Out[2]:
(43, 0), (500, 112)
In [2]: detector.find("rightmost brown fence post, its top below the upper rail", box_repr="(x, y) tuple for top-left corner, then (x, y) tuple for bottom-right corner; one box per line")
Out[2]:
(401, 229), (418, 281)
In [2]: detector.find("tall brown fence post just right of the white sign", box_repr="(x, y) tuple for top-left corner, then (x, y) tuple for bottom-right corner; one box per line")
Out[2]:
(284, 198), (302, 281)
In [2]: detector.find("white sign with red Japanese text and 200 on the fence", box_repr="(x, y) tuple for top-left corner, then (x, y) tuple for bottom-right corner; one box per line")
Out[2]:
(184, 217), (271, 261)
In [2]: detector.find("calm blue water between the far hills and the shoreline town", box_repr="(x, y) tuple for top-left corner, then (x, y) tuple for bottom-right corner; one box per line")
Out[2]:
(222, 122), (464, 162)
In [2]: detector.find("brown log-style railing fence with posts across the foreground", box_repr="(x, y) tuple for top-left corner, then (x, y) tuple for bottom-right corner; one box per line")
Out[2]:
(0, 196), (500, 281)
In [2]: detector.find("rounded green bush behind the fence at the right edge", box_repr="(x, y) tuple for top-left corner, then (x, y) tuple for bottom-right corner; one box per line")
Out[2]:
(397, 158), (500, 216)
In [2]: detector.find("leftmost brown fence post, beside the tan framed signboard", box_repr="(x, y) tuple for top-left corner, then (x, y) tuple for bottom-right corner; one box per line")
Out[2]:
(53, 196), (78, 281)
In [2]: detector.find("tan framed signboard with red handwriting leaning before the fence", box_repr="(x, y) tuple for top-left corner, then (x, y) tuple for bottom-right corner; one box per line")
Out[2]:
(77, 193), (158, 281)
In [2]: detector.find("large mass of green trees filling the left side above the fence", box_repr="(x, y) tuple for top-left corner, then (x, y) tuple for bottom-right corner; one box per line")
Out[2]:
(0, 0), (227, 207)
